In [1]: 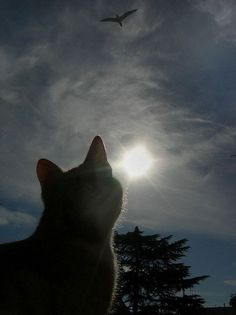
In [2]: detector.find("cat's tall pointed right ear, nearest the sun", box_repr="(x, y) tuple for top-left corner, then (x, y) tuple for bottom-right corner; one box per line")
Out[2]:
(84, 136), (108, 164)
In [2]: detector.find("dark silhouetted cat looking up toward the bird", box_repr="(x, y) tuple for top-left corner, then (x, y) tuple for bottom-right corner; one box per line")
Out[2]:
(0, 136), (123, 315)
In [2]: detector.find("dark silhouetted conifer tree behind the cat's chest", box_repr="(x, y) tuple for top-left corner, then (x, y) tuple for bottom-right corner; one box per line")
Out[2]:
(112, 227), (207, 315)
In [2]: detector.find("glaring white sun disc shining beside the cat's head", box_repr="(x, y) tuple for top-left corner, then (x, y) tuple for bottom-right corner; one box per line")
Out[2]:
(121, 146), (153, 178)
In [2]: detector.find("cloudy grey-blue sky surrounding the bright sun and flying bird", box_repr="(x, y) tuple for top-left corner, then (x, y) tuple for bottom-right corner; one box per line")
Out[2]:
(0, 0), (236, 306)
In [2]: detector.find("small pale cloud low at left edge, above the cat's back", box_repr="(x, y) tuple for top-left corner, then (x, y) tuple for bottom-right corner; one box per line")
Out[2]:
(0, 206), (36, 227)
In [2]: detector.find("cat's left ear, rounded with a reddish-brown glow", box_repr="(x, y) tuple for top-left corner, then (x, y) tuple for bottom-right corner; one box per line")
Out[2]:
(36, 159), (63, 185)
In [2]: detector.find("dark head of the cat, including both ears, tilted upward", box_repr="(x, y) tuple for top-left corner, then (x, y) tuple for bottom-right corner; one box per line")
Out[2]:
(37, 136), (122, 239)
